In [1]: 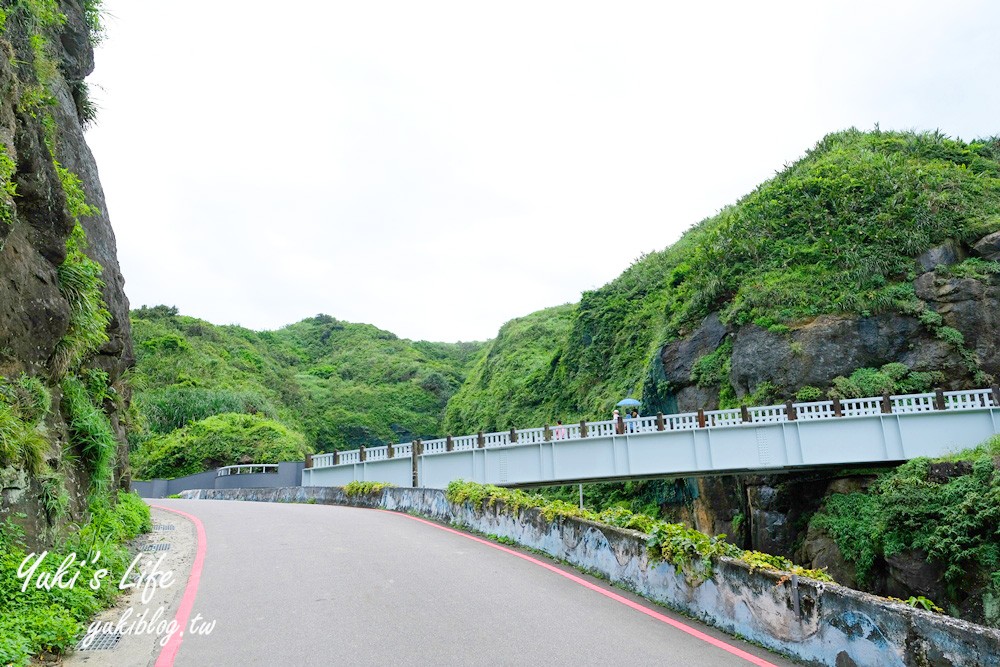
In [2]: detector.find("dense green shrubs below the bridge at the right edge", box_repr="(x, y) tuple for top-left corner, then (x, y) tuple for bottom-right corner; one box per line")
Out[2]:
(812, 436), (1000, 627)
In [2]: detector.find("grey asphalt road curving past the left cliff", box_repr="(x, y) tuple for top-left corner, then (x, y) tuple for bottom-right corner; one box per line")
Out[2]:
(153, 500), (795, 667)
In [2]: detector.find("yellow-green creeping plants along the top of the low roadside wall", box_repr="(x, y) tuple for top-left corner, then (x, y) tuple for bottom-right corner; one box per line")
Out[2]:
(445, 480), (833, 584)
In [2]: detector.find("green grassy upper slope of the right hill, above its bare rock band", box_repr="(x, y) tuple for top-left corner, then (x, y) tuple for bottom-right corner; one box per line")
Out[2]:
(447, 130), (1000, 431)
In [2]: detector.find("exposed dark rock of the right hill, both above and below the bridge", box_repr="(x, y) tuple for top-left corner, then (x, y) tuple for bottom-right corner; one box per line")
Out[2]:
(647, 233), (1000, 618)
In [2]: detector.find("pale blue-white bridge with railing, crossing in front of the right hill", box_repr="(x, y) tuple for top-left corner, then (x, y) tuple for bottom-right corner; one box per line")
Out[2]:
(302, 386), (1000, 488)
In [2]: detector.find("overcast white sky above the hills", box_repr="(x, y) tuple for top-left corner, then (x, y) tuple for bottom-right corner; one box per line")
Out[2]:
(88, 0), (1000, 341)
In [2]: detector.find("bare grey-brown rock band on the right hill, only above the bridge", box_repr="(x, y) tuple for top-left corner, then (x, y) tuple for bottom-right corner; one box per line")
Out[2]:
(655, 233), (1000, 412)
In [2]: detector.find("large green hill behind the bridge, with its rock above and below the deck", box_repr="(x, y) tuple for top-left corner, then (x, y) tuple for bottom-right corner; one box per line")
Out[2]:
(448, 129), (1000, 628)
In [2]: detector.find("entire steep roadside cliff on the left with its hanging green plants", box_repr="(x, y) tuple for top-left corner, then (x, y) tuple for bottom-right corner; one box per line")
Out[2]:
(0, 0), (132, 540)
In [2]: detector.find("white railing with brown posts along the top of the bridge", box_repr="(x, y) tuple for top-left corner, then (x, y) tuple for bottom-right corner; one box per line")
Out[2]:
(306, 387), (1000, 475)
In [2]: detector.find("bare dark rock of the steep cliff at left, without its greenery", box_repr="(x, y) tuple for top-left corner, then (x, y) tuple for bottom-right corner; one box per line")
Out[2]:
(0, 0), (132, 538)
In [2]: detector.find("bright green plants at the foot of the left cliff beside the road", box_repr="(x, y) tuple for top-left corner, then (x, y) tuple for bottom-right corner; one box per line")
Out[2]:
(0, 492), (152, 667)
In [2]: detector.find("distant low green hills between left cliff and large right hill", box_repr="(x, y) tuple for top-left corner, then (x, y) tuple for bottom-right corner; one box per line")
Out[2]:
(130, 306), (481, 476)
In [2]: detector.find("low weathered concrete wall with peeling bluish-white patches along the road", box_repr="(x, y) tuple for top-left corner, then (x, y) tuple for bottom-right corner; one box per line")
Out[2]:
(182, 487), (1000, 667)
